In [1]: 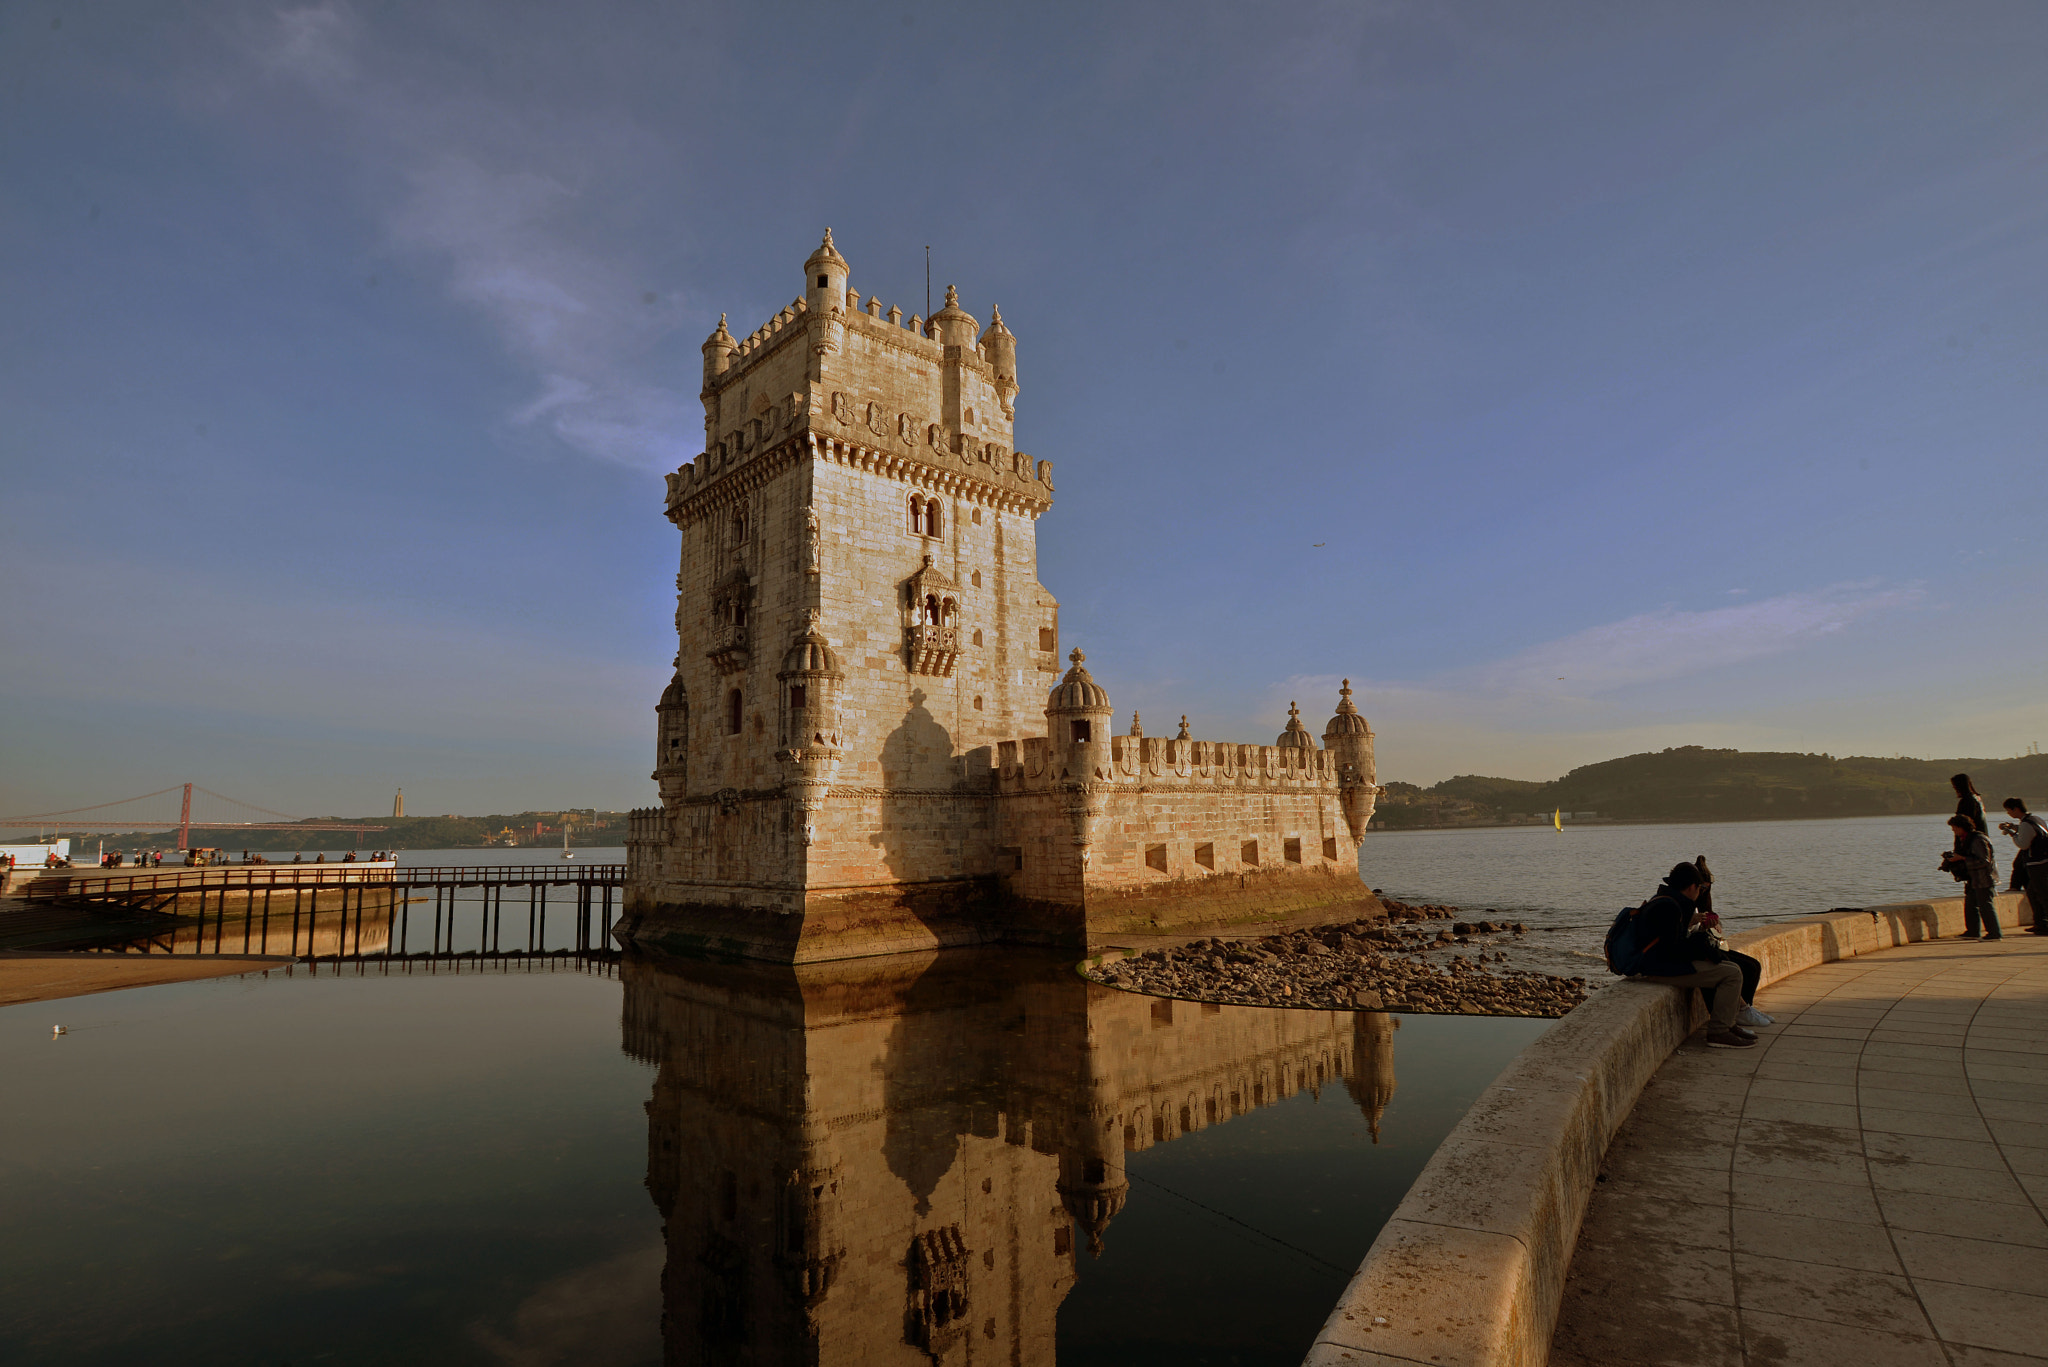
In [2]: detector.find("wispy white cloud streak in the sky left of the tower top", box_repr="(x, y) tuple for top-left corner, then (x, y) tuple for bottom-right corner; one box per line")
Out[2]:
(248, 0), (698, 469)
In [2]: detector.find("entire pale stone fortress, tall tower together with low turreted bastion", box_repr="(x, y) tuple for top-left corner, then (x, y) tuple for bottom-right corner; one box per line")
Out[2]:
(623, 232), (1380, 961)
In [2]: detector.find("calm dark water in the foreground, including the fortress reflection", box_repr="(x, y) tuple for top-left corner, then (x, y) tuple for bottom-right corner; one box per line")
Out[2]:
(0, 950), (1546, 1367)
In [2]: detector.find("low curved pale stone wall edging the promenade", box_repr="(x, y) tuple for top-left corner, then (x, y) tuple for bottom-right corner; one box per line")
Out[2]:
(1307, 894), (2025, 1367)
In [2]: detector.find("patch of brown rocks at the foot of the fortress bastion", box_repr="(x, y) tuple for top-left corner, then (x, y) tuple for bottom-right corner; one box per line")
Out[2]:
(1087, 898), (1587, 1017)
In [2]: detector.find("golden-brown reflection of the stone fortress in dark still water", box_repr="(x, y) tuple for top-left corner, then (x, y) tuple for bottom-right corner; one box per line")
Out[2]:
(623, 951), (1393, 1367)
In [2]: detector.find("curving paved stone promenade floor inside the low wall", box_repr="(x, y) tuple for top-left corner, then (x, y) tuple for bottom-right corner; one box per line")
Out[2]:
(1550, 928), (2048, 1367)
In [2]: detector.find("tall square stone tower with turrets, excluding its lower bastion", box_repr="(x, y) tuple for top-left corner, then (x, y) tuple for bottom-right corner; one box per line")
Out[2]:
(641, 232), (1059, 963)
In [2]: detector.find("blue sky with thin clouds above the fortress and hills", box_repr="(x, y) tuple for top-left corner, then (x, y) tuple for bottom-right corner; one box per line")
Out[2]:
(0, 0), (2048, 814)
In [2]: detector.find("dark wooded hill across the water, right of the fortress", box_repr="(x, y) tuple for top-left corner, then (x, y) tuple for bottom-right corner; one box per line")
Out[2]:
(1372, 746), (2048, 830)
